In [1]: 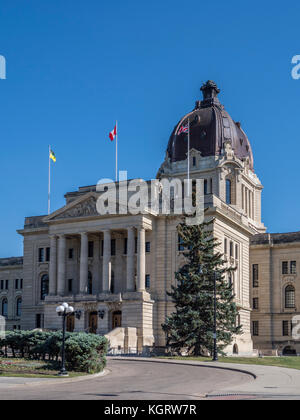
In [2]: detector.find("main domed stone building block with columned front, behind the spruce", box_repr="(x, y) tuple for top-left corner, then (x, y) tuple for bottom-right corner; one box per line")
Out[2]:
(0, 81), (288, 355)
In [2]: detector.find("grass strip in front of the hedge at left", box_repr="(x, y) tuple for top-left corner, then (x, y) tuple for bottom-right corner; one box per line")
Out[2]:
(0, 358), (86, 379)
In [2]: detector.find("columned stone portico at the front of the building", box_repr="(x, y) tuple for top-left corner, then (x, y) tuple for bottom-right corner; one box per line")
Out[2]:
(40, 203), (154, 347)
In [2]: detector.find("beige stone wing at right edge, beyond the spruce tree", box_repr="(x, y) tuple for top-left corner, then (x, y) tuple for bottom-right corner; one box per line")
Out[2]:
(250, 232), (300, 355)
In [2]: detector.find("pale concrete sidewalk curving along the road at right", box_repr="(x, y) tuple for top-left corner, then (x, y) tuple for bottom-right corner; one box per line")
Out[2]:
(112, 357), (300, 400)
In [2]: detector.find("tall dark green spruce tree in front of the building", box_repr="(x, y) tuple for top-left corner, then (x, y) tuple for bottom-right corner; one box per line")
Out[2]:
(162, 220), (242, 356)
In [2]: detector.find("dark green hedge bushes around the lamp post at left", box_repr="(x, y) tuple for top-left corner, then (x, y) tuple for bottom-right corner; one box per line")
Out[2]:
(0, 331), (108, 373)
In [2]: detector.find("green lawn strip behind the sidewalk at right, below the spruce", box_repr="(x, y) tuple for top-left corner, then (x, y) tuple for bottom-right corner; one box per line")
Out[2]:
(164, 356), (300, 369)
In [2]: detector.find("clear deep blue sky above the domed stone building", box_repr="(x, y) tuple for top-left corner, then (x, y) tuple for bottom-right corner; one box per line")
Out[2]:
(0, 0), (300, 257)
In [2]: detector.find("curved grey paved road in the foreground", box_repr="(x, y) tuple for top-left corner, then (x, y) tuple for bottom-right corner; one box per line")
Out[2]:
(0, 358), (254, 400)
